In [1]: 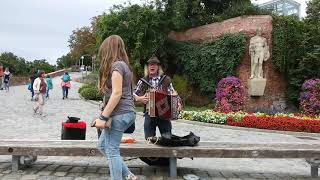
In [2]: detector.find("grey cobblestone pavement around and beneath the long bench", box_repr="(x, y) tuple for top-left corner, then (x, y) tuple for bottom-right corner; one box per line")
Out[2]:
(0, 73), (319, 180)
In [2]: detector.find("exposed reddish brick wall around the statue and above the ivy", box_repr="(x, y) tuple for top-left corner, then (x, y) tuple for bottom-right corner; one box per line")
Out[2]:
(169, 15), (286, 111)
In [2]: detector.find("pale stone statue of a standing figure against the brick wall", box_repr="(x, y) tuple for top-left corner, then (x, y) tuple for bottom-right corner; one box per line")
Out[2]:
(249, 28), (270, 79)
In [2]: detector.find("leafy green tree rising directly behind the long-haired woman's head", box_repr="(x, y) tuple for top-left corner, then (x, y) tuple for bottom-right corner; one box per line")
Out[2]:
(95, 5), (168, 73)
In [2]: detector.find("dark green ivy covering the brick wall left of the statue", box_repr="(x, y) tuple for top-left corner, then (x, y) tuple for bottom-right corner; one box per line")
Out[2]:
(159, 34), (246, 95)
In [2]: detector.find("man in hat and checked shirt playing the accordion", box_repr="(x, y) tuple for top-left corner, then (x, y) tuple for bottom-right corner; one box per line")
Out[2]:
(133, 57), (181, 139)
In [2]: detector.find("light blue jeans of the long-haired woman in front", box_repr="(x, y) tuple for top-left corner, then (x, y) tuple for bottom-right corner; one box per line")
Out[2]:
(98, 112), (136, 180)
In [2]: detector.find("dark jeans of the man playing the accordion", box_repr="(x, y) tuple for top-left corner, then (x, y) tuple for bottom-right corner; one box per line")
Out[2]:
(144, 113), (172, 139)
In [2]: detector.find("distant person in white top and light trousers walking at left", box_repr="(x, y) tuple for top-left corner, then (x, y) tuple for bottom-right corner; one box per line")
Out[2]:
(33, 71), (47, 117)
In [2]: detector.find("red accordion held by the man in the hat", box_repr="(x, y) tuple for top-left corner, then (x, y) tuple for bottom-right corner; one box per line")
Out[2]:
(147, 89), (179, 120)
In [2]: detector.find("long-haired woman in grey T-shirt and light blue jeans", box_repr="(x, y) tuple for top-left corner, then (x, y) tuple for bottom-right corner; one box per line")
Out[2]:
(94, 35), (137, 180)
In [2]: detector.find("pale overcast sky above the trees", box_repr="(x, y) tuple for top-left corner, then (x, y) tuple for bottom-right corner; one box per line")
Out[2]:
(0, 0), (310, 64)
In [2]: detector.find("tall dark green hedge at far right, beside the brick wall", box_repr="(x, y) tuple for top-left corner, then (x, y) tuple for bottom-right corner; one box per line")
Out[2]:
(272, 16), (320, 106)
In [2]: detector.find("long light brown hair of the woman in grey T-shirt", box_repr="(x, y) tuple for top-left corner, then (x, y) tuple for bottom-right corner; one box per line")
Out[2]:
(98, 35), (129, 93)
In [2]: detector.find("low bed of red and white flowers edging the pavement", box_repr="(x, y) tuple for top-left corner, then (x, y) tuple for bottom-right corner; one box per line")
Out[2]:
(181, 110), (320, 133)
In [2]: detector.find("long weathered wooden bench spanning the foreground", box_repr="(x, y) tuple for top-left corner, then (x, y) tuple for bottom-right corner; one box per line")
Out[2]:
(0, 140), (320, 177)
